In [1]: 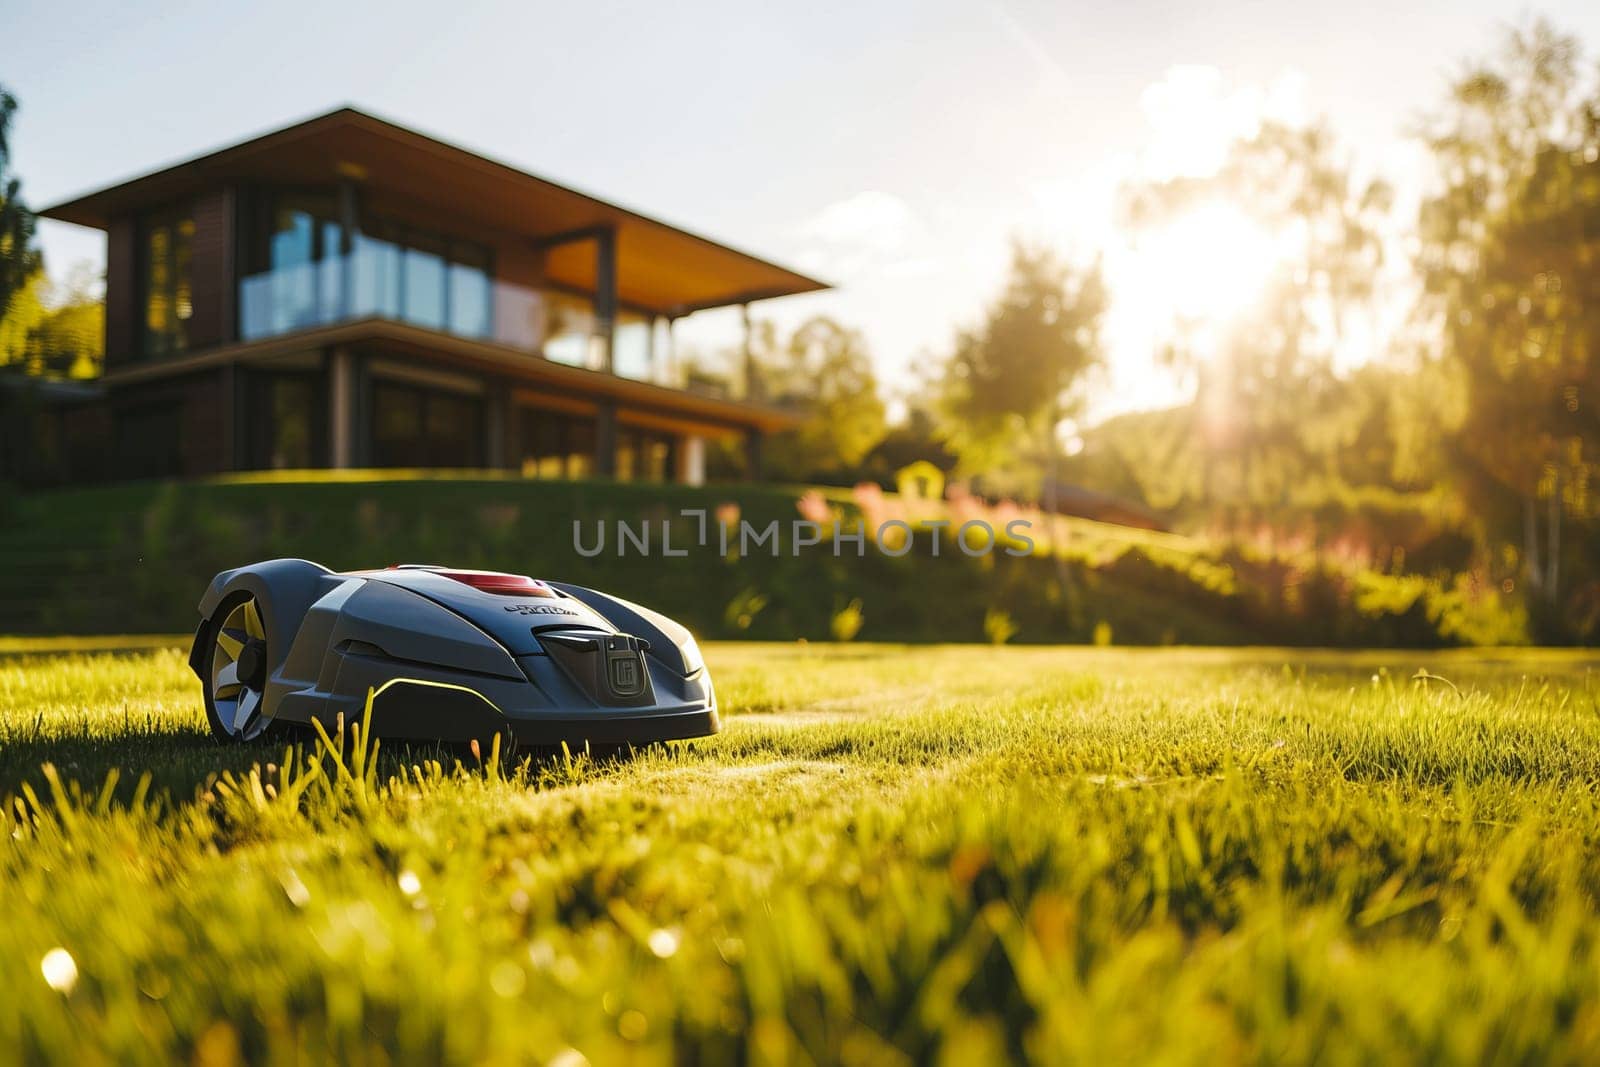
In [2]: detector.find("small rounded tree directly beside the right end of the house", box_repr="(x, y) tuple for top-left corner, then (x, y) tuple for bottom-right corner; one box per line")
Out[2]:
(752, 315), (886, 482)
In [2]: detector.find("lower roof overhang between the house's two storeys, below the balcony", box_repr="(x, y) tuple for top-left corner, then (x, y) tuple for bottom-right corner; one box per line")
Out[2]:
(99, 318), (800, 434)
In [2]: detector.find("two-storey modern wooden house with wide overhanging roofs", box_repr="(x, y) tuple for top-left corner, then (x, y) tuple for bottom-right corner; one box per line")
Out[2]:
(15, 109), (826, 483)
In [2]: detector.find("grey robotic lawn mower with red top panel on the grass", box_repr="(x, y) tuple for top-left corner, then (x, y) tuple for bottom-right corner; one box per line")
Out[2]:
(189, 560), (720, 749)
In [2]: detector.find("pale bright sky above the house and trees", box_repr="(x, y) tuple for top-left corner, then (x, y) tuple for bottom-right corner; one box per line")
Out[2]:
(9, 0), (1600, 418)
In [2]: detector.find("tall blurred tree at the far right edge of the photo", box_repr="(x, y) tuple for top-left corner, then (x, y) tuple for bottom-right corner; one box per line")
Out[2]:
(1419, 21), (1600, 625)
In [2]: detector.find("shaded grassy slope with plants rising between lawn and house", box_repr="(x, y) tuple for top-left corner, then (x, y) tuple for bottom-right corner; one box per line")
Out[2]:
(0, 472), (1526, 646)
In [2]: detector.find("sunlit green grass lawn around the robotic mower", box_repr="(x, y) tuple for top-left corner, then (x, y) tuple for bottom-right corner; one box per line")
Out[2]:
(0, 638), (1600, 1065)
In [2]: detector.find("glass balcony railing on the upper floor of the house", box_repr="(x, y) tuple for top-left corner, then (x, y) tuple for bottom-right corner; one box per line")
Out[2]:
(238, 248), (682, 387)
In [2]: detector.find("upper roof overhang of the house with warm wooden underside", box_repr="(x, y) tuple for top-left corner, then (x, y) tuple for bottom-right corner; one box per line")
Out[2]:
(40, 107), (829, 315)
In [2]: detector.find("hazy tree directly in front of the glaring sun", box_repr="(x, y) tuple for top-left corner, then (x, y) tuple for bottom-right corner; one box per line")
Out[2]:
(1126, 123), (1390, 507)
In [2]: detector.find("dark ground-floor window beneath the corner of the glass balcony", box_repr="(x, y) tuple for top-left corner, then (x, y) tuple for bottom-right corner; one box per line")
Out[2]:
(373, 382), (483, 467)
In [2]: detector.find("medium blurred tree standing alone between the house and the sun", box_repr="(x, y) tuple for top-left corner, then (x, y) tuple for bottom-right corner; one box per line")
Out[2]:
(936, 243), (1107, 486)
